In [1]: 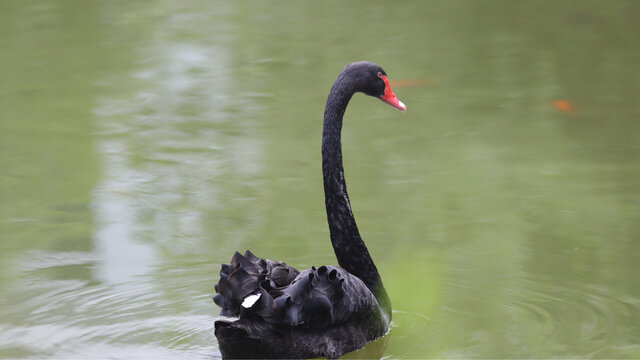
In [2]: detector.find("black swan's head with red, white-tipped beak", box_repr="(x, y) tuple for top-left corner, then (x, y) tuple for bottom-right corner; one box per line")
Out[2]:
(342, 61), (407, 111)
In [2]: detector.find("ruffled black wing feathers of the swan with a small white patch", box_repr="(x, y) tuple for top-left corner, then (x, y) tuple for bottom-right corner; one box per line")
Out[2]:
(213, 251), (378, 328)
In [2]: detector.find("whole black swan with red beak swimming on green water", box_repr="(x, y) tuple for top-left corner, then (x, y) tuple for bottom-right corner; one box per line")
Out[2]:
(213, 61), (406, 358)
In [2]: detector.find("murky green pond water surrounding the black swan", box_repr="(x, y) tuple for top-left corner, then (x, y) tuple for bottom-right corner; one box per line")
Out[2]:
(0, 0), (640, 359)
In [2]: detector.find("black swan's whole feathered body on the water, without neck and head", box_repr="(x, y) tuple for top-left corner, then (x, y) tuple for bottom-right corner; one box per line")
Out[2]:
(214, 251), (389, 358)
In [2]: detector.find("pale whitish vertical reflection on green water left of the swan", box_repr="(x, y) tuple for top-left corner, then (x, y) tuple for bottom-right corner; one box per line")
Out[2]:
(94, 39), (254, 283)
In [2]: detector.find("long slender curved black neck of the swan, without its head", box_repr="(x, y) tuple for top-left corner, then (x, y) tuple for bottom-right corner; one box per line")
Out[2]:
(322, 74), (391, 315)
